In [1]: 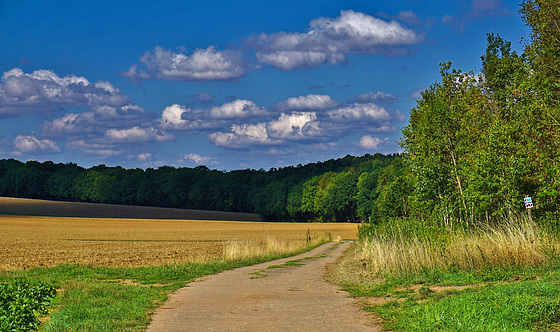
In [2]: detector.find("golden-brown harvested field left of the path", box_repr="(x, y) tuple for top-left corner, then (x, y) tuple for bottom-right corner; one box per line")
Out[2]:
(0, 215), (357, 271)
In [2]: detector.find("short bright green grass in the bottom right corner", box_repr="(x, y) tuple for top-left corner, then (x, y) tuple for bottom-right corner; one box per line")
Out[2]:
(367, 281), (560, 331)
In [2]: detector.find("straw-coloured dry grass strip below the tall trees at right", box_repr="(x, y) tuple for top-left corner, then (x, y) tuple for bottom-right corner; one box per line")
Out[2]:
(356, 221), (560, 274)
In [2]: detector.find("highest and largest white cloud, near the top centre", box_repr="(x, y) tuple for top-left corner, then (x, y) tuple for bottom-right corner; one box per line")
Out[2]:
(246, 10), (424, 70)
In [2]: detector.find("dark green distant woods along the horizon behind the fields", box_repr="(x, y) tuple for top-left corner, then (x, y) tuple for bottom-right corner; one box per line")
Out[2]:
(0, 154), (401, 222)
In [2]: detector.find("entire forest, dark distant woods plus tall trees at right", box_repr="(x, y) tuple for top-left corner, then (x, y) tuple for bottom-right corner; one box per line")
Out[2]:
(0, 0), (560, 226)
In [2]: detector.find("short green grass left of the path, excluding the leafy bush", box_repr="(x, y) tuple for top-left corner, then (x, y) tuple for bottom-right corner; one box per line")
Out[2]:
(0, 243), (328, 332)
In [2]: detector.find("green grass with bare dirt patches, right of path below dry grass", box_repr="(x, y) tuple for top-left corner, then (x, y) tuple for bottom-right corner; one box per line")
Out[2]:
(345, 267), (560, 332)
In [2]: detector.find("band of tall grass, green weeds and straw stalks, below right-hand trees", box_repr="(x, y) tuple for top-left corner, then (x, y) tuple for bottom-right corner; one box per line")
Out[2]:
(360, 219), (560, 275)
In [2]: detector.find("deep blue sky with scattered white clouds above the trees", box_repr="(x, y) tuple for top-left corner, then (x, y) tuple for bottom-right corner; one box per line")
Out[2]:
(0, 0), (530, 171)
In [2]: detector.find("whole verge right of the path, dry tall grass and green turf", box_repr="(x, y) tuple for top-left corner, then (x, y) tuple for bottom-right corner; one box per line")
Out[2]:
(331, 219), (560, 331)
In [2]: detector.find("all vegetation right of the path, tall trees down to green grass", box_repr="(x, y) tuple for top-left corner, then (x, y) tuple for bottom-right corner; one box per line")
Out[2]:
(332, 0), (560, 331)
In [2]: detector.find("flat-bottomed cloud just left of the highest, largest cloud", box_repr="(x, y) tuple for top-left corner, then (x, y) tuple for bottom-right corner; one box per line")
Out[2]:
(121, 46), (248, 81)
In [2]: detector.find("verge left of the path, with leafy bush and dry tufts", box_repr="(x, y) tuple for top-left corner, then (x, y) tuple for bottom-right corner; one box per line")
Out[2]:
(0, 235), (330, 332)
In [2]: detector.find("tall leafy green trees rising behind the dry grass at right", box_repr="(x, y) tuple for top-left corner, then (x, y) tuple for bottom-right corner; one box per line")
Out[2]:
(394, 0), (560, 225)
